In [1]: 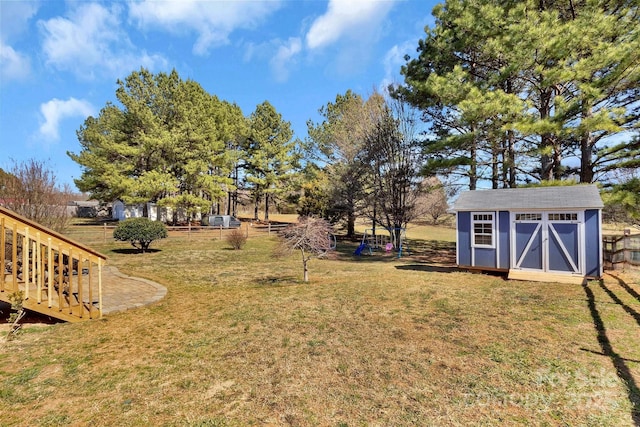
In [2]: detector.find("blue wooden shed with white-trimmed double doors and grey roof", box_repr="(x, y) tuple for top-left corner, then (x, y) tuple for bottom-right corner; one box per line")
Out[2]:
(452, 185), (604, 283)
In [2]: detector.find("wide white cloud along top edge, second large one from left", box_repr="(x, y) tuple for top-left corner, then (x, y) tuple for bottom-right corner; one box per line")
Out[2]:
(129, 0), (281, 55)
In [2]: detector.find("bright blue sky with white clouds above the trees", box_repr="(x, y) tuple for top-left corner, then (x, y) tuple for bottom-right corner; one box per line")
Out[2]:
(0, 0), (437, 191)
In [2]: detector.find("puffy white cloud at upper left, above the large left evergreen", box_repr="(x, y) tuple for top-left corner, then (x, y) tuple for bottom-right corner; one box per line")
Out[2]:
(39, 3), (166, 79)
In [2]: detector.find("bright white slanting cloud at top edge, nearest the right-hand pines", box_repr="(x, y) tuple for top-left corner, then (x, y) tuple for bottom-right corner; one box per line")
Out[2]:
(306, 0), (394, 49)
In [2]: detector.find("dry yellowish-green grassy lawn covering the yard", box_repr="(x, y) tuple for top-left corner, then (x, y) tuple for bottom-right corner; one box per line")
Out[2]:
(0, 226), (640, 426)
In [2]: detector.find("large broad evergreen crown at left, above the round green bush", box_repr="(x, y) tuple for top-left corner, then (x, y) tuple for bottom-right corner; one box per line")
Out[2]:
(68, 69), (240, 222)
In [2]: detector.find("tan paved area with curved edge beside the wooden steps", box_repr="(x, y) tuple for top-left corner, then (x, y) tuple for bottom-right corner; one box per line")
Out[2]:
(102, 265), (167, 315)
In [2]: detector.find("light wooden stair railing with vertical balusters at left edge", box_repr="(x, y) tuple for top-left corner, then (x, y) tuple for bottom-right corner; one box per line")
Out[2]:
(0, 207), (106, 321)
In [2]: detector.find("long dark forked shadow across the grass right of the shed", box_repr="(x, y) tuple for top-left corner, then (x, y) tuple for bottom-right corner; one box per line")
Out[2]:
(582, 280), (640, 426)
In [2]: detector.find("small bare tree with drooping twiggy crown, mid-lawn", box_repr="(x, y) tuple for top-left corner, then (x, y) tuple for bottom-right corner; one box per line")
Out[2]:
(279, 217), (333, 282)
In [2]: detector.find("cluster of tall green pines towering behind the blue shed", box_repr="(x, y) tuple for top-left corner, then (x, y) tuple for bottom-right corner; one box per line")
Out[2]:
(396, 0), (640, 189)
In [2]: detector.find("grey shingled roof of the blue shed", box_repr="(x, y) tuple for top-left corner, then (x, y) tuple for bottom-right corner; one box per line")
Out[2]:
(451, 184), (604, 212)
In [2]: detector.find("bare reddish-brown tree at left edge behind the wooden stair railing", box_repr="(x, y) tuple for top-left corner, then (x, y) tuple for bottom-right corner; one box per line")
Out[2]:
(0, 159), (73, 232)
